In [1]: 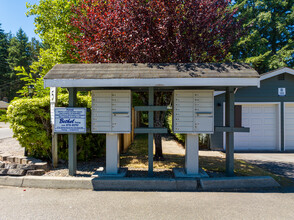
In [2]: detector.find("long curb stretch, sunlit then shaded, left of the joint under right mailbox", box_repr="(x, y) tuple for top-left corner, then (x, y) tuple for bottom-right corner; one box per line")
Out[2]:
(0, 176), (198, 191)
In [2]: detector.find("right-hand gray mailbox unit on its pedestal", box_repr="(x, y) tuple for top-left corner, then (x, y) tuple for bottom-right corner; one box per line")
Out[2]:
(173, 90), (214, 176)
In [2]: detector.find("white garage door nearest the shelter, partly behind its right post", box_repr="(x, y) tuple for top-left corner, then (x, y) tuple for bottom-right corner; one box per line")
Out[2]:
(226, 104), (279, 150)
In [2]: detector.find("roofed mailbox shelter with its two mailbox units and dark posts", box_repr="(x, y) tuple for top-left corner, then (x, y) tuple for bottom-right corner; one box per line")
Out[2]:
(44, 63), (259, 177)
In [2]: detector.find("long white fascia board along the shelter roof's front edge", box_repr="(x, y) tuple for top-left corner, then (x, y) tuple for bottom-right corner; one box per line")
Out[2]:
(44, 78), (260, 88)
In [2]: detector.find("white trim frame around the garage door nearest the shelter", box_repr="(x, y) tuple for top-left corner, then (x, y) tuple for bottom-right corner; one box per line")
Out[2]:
(223, 102), (285, 151)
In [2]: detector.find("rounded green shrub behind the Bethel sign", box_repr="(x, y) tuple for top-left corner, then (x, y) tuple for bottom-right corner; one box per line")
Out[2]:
(7, 94), (105, 160)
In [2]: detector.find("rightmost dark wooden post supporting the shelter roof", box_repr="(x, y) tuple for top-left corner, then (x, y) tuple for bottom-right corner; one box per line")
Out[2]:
(225, 87), (235, 176)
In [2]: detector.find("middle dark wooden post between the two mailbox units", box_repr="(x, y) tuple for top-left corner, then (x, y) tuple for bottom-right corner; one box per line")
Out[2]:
(148, 87), (154, 177)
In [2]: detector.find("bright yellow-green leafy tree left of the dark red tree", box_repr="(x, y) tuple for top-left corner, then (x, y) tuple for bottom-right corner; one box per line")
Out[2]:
(17, 0), (79, 97)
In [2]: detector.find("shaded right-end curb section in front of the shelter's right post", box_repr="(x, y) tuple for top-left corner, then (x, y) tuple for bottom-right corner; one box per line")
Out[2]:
(200, 176), (281, 190)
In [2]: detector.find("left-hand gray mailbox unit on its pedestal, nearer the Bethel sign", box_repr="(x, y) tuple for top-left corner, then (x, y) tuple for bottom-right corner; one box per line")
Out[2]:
(91, 90), (132, 175)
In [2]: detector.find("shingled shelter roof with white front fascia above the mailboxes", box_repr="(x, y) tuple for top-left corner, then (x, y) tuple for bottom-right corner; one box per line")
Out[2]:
(44, 63), (259, 87)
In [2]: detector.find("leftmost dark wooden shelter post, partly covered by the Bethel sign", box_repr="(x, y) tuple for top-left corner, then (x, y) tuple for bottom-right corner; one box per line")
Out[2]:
(68, 88), (77, 176)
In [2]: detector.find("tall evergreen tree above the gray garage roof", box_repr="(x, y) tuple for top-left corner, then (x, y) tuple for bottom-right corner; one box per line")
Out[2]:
(232, 0), (294, 73)
